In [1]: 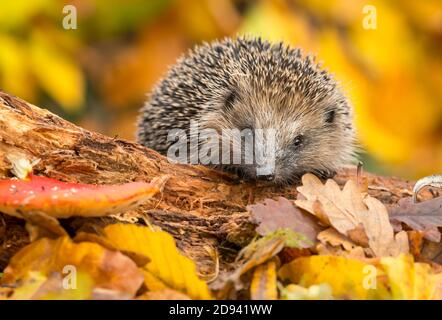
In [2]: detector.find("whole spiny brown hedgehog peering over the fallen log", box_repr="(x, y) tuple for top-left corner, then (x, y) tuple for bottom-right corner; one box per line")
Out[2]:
(137, 36), (356, 184)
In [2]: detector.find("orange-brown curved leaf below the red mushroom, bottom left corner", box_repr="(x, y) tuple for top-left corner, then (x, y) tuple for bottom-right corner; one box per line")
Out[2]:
(2, 237), (144, 296)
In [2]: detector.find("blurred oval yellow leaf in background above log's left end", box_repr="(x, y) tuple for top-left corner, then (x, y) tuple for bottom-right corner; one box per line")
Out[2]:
(29, 32), (85, 112)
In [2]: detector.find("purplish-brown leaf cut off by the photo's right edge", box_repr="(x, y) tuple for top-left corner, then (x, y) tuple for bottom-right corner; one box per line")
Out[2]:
(389, 197), (442, 242)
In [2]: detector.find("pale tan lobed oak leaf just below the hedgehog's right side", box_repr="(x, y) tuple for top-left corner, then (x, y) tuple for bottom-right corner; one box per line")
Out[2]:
(295, 173), (408, 257)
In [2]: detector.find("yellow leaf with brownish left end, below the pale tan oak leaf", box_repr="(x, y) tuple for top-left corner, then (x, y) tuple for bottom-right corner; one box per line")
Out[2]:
(279, 256), (390, 299)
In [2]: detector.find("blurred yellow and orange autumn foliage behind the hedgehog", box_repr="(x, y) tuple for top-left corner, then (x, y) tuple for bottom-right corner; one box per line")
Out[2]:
(0, 0), (442, 178)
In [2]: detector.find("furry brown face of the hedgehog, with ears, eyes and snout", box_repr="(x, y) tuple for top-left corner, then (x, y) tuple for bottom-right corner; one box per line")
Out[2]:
(202, 77), (354, 184)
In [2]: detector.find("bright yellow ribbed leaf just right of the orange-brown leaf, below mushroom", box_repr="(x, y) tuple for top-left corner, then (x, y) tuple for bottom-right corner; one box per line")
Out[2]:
(104, 224), (211, 299)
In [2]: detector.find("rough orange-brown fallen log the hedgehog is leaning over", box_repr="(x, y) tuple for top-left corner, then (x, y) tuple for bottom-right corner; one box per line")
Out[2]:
(0, 92), (428, 274)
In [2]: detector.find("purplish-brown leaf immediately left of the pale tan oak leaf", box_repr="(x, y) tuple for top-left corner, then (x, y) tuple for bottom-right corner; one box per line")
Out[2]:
(247, 197), (321, 248)
